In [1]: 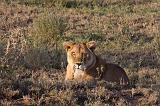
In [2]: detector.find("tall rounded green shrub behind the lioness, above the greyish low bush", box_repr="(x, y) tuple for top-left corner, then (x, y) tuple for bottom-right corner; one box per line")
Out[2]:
(31, 12), (67, 48)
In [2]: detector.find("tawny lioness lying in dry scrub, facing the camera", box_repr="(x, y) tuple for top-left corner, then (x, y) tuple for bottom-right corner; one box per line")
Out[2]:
(63, 41), (129, 85)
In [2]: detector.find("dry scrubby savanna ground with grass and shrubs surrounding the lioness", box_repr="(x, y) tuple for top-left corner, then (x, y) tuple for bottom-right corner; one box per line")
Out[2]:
(0, 0), (160, 106)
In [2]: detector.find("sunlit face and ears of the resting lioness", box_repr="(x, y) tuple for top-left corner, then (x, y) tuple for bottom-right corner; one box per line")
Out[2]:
(64, 41), (96, 71)
